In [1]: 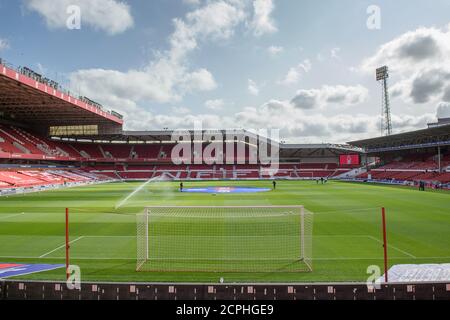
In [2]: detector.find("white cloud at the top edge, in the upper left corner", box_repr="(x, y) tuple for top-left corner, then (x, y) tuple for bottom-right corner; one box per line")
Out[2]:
(24, 0), (134, 35)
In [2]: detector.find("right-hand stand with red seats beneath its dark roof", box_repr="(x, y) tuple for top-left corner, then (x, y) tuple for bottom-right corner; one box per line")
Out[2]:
(350, 123), (450, 188)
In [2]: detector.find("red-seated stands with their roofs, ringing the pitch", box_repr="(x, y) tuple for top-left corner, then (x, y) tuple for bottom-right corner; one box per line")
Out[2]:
(0, 57), (450, 189)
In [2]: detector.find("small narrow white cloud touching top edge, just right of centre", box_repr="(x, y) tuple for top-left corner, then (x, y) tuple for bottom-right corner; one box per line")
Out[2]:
(251, 0), (277, 37)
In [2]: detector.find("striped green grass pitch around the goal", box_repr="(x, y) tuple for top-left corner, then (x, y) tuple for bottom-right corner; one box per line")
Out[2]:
(0, 181), (450, 283)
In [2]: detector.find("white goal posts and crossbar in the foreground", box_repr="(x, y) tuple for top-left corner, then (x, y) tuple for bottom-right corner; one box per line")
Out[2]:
(136, 205), (313, 273)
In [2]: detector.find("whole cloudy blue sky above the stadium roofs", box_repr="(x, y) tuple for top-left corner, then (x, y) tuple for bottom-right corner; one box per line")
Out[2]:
(0, 0), (450, 142)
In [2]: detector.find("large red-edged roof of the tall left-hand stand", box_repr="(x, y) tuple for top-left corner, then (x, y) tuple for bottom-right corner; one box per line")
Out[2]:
(0, 59), (123, 127)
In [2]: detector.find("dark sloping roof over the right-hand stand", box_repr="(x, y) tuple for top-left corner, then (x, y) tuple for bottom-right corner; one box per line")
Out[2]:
(349, 123), (450, 153)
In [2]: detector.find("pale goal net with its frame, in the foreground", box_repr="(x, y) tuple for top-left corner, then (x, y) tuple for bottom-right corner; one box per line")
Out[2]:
(137, 206), (313, 273)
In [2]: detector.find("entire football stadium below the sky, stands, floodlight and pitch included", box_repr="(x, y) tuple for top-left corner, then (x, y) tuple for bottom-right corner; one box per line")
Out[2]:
(0, 1), (450, 300)
